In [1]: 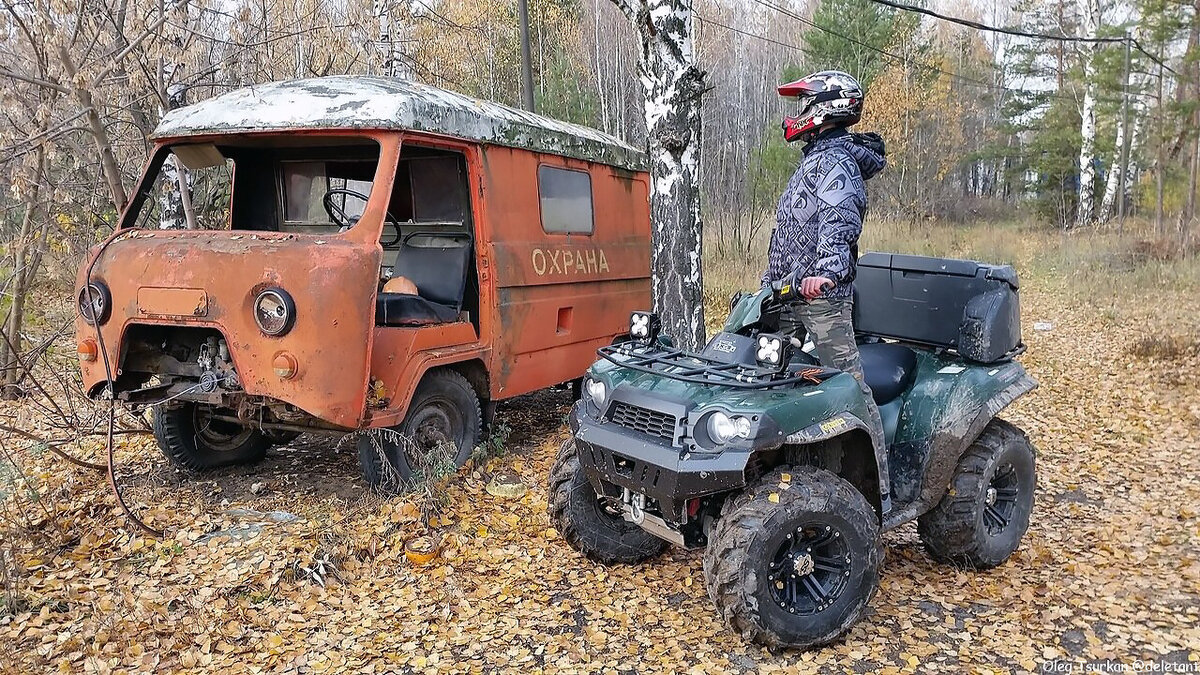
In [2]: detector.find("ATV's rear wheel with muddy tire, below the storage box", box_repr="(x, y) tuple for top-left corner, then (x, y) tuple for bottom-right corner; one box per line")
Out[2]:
(917, 419), (1036, 569)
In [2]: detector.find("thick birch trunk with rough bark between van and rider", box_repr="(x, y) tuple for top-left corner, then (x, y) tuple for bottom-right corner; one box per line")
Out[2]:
(613, 0), (704, 350)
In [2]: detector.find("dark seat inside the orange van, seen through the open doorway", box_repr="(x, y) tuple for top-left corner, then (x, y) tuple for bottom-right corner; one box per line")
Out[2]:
(376, 232), (472, 325)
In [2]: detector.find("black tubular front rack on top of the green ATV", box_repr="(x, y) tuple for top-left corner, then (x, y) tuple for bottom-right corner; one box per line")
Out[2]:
(596, 342), (841, 389)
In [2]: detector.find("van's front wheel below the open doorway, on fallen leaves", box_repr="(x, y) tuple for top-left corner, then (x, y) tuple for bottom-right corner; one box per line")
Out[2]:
(358, 370), (482, 495)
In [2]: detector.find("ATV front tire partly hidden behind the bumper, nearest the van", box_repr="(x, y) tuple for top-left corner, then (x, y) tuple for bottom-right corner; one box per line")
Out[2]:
(550, 438), (667, 565)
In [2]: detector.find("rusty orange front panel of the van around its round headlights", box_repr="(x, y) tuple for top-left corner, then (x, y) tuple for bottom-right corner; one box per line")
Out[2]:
(76, 229), (380, 428)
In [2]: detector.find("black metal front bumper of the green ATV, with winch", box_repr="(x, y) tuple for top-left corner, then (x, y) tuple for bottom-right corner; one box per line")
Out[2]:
(571, 405), (750, 524)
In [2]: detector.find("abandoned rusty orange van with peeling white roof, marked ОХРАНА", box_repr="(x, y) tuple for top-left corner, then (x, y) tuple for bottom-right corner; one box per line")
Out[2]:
(76, 77), (650, 486)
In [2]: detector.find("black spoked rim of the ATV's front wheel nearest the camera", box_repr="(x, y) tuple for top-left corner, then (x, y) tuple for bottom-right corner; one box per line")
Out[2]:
(767, 524), (852, 616)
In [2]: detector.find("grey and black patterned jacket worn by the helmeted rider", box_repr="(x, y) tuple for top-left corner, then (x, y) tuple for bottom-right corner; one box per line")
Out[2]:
(762, 127), (887, 298)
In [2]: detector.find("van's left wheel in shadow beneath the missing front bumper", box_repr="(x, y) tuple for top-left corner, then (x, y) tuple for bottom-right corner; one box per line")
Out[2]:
(152, 402), (271, 472)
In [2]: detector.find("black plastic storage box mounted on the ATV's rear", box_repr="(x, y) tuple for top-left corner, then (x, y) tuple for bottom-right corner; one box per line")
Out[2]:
(854, 253), (1021, 363)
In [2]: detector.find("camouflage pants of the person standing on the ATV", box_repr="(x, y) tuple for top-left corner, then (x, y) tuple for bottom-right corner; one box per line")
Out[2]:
(779, 298), (884, 444)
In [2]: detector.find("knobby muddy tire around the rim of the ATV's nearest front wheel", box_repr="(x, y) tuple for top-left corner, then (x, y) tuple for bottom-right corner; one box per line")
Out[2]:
(704, 466), (883, 649)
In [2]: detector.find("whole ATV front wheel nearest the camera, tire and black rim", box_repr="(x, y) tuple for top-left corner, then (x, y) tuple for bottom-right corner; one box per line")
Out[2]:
(704, 466), (883, 649)
